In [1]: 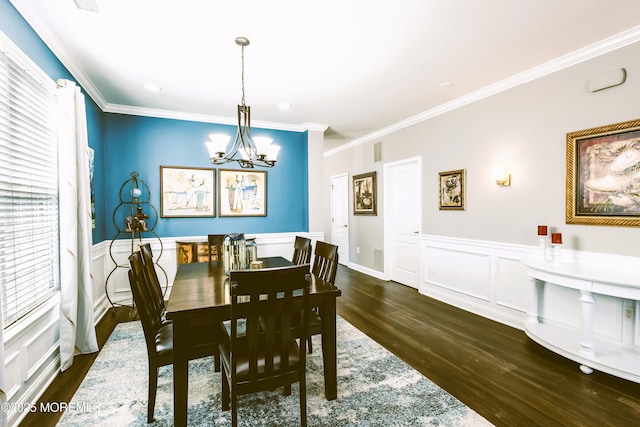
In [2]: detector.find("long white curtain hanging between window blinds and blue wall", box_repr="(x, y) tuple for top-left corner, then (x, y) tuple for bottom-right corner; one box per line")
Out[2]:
(58, 80), (98, 371)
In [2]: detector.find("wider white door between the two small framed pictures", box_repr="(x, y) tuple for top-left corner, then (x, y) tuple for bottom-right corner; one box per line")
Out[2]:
(384, 157), (422, 289)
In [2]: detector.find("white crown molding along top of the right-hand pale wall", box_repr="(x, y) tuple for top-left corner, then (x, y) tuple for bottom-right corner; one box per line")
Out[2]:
(324, 25), (640, 157)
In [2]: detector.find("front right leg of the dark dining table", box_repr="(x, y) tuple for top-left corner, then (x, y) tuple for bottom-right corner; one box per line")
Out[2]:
(320, 298), (338, 400)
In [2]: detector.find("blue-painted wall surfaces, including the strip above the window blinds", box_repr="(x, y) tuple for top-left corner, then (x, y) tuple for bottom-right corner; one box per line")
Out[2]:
(0, 0), (309, 243)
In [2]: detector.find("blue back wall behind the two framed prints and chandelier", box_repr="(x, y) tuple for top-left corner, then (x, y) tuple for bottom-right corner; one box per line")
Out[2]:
(104, 114), (309, 238)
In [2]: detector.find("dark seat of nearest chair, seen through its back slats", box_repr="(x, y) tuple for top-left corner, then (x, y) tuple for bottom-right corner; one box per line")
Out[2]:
(220, 336), (300, 380)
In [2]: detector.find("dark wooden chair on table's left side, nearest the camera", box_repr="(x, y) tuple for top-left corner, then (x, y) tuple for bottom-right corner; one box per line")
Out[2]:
(128, 251), (225, 423)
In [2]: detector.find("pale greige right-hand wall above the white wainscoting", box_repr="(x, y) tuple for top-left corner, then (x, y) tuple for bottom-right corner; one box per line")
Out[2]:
(324, 43), (640, 268)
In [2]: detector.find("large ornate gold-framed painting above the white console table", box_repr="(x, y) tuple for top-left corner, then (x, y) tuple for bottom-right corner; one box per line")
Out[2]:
(565, 115), (640, 226)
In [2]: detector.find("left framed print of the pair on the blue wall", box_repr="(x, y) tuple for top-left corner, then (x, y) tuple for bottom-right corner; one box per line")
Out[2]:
(160, 166), (216, 218)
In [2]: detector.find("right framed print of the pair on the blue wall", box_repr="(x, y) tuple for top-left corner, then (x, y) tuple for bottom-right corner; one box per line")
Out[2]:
(218, 169), (267, 217)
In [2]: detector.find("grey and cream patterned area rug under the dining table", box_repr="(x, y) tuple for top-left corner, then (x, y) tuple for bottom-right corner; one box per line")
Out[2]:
(58, 317), (491, 427)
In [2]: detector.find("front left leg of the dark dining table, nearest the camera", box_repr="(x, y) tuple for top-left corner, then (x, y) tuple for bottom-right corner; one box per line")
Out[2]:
(173, 320), (189, 426)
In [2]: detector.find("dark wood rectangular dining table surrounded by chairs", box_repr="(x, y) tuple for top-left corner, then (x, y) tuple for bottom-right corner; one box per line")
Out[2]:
(166, 257), (341, 426)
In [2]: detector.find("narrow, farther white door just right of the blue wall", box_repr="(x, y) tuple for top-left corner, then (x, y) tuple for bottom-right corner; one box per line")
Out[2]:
(331, 174), (349, 265)
